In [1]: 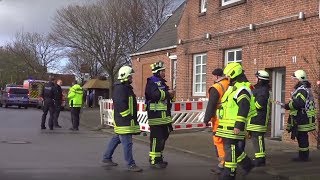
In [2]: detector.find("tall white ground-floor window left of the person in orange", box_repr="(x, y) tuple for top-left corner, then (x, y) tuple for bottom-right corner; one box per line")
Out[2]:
(192, 54), (207, 96)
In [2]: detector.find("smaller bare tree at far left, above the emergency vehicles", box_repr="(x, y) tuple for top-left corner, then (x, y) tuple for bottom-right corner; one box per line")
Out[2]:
(8, 32), (60, 74)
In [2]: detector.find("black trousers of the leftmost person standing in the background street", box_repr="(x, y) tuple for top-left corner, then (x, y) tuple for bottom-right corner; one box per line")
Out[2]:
(41, 99), (55, 129)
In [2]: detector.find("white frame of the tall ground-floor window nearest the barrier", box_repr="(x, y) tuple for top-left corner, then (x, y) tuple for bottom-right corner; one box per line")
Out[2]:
(192, 53), (208, 96)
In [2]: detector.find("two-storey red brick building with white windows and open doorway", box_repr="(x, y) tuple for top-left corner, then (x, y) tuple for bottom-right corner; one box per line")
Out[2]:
(133, 0), (320, 141)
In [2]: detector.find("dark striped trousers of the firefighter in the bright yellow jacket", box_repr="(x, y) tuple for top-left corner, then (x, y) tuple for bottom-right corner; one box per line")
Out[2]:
(220, 138), (253, 180)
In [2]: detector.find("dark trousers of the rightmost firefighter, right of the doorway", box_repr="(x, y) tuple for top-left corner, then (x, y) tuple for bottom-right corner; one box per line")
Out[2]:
(297, 131), (309, 160)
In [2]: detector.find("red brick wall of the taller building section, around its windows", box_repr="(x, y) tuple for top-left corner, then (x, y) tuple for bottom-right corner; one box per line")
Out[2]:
(177, 0), (320, 142)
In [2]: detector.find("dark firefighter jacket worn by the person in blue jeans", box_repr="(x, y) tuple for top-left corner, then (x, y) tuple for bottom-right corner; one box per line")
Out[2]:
(112, 82), (140, 134)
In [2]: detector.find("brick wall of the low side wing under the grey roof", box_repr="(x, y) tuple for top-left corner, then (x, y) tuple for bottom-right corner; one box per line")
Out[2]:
(131, 49), (176, 97)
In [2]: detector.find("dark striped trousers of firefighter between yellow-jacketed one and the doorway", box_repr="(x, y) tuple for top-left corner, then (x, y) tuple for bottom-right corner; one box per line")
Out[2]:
(250, 131), (266, 165)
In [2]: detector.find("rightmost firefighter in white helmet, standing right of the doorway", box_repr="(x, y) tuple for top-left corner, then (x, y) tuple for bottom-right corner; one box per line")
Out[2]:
(283, 70), (316, 161)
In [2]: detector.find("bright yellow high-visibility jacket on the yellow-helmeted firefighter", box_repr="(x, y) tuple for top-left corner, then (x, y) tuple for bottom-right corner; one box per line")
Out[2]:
(216, 82), (257, 140)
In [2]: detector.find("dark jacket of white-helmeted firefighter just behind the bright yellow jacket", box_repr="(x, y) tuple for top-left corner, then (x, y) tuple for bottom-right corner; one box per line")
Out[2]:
(247, 83), (271, 132)
